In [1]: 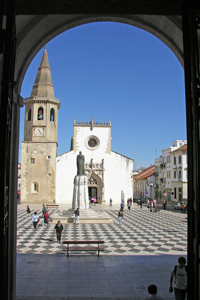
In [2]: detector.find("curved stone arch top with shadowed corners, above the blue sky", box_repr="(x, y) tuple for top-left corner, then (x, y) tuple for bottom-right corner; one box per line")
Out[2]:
(15, 14), (183, 94)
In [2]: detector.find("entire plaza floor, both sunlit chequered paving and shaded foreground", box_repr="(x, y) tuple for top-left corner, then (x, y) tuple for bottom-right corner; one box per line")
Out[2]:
(16, 204), (187, 300)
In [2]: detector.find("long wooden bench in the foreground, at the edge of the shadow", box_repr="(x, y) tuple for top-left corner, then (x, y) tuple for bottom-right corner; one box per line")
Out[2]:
(63, 241), (104, 257)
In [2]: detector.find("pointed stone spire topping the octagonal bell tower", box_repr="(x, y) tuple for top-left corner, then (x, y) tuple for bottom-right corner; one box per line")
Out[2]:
(31, 46), (55, 99)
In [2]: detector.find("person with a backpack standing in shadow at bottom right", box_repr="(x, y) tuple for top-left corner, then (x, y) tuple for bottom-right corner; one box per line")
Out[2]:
(169, 256), (187, 300)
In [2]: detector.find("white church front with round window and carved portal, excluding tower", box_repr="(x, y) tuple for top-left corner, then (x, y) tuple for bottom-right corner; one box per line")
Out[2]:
(56, 118), (134, 203)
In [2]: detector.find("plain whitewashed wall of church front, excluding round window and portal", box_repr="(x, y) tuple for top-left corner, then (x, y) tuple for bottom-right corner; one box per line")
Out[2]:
(56, 124), (133, 204)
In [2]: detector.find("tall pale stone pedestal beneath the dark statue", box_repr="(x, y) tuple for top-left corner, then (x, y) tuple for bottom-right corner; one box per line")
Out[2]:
(72, 175), (89, 210)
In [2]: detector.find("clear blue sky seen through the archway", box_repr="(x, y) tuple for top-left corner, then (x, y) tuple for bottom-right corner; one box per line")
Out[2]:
(19, 22), (186, 169)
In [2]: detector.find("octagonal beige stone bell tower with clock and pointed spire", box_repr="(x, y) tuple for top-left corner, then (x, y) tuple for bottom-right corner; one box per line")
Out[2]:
(21, 47), (60, 203)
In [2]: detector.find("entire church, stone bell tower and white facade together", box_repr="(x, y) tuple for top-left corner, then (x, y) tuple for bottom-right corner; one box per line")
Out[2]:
(21, 48), (134, 204)
